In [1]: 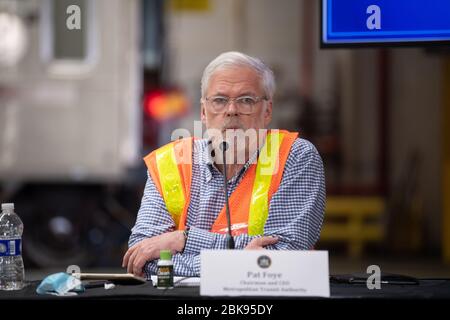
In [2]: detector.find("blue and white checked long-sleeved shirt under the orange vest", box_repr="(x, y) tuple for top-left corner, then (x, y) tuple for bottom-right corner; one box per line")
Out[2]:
(128, 138), (325, 277)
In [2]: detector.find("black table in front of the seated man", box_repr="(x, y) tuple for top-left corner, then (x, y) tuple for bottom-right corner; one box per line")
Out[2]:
(0, 279), (450, 319)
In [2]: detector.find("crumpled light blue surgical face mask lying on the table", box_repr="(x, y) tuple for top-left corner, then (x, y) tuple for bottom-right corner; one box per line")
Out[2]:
(36, 272), (84, 295)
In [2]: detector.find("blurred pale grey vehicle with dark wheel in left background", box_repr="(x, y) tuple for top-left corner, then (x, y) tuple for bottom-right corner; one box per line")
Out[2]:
(0, 0), (145, 267)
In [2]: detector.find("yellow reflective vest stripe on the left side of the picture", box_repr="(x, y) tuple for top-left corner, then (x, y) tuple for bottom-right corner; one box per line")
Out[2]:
(156, 143), (186, 228)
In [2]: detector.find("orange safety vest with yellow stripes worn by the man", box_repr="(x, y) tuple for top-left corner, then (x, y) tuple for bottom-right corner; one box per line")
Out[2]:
(144, 130), (298, 235)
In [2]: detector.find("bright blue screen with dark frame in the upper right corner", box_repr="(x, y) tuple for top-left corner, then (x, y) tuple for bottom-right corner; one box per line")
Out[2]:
(322, 0), (450, 44)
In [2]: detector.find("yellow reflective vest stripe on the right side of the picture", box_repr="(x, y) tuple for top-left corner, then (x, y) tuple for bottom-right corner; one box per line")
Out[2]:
(248, 132), (284, 236)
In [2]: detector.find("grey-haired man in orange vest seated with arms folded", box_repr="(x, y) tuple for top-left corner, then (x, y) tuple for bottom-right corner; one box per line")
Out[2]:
(123, 52), (325, 277)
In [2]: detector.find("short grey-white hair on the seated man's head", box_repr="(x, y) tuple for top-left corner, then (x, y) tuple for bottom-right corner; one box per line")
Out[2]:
(201, 51), (275, 99)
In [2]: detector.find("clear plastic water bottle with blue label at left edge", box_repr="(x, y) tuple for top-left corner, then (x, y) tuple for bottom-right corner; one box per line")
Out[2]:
(0, 203), (25, 290)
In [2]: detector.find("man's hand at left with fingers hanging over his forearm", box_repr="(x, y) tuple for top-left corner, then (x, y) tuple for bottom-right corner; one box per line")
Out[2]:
(122, 230), (186, 276)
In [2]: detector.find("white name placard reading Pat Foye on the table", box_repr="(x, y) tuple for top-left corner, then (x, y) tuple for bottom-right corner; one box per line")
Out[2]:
(200, 250), (330, 297)
